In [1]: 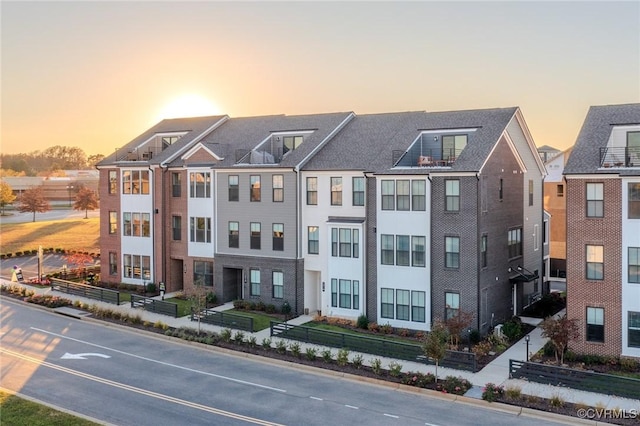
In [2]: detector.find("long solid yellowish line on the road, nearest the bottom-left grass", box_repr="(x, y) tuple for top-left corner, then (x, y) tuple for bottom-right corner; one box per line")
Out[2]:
(0, 348), (279, 426)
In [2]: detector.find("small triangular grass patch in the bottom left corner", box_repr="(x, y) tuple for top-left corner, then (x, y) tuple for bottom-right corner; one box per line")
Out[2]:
(0, 391), (98, 426)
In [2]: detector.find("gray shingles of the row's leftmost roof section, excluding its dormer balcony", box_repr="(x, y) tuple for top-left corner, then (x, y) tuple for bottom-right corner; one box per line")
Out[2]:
(97, 115), (225, 167)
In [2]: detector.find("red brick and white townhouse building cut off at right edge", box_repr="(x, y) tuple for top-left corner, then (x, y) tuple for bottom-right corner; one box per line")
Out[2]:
(564, 104), (640, 357)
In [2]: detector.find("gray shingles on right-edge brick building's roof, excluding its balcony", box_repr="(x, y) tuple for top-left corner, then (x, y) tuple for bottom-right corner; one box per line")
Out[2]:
(564, 104), (640, 176)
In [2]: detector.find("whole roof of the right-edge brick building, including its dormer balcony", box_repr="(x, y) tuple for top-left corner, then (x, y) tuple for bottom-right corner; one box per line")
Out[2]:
(564, 104), (640, 176)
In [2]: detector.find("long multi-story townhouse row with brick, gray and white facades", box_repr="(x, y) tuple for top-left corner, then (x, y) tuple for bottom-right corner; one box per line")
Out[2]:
(99, 108), (544, 332)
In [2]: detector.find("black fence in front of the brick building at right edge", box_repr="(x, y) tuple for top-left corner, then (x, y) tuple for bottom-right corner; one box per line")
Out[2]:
(509, 359), (640, 399)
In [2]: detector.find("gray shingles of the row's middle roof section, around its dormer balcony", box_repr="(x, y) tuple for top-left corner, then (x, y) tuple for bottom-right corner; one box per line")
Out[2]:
(171, 112), (352, 168)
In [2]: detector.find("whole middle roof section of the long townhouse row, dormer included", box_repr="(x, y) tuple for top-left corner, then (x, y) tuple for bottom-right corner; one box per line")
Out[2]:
(171, 112), (353, 168)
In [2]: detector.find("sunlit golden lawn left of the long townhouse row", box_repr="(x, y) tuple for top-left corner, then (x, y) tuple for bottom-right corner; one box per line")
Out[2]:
(0, 215), (100, 253)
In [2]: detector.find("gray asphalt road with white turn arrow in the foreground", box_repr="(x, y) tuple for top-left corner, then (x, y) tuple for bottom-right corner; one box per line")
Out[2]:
(0, 298), (568, 426)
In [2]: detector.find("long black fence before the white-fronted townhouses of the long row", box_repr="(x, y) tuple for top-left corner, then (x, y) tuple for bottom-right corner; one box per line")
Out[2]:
(270, 321), (477, 372)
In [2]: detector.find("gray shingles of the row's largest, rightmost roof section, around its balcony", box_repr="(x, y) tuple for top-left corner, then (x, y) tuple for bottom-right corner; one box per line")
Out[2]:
(303, 107), (517, 173)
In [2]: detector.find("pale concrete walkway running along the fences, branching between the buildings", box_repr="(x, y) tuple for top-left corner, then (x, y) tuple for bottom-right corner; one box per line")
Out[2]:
(5, 279), (640, 410)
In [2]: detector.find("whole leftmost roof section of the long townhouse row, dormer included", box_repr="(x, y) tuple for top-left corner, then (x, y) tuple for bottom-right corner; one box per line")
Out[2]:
(96, 115), (228, 168)
